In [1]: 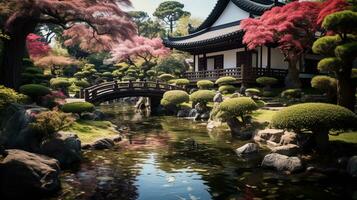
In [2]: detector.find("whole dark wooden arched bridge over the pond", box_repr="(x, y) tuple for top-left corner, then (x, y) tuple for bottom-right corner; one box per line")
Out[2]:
(81, 81), (184, 107)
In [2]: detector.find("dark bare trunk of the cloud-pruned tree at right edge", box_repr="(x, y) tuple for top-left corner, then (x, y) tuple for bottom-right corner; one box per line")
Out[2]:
(337, 72), (356, 111)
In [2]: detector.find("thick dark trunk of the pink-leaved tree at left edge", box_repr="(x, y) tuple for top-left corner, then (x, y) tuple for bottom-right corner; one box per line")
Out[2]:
(0, 18), (36, 89)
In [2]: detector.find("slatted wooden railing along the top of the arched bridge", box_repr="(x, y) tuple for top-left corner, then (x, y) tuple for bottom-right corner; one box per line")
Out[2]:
(80, 81), (184, 101)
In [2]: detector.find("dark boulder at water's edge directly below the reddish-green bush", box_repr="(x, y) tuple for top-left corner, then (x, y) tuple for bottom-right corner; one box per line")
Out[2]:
(41, 132), (81, 168)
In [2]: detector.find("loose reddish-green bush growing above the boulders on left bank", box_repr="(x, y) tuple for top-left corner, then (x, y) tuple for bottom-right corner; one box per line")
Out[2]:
(30, 111), (74, 138)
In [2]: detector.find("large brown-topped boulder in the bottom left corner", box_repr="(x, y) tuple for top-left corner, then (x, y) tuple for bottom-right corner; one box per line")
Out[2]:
(0, 150), (60, 199)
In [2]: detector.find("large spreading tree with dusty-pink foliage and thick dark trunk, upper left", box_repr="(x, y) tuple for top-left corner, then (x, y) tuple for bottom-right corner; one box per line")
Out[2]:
(0, 0), (136, 88)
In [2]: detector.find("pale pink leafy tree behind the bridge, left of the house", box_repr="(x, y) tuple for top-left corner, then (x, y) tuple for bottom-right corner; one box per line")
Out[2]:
(108, 36), (170, 69)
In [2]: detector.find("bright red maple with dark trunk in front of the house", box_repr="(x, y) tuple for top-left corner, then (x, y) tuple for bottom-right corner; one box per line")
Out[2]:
(241, 1), (321, 88)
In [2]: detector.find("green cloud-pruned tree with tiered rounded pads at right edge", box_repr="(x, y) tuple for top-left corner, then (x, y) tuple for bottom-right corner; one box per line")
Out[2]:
(313, 10), (357, 110)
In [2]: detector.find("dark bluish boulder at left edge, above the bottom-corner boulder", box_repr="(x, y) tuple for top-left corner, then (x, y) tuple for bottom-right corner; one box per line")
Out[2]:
(0, 104), (47, 152)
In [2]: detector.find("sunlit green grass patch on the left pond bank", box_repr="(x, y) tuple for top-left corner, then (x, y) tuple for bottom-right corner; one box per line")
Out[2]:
(67, 120), (118, 143)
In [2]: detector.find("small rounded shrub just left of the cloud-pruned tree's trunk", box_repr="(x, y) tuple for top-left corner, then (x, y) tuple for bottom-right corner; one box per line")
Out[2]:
(311, 76), (337, 96)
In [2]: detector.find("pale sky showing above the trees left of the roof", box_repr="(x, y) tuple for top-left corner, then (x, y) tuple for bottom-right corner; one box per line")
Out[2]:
(131, 0), (217, 20)
